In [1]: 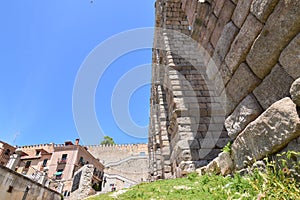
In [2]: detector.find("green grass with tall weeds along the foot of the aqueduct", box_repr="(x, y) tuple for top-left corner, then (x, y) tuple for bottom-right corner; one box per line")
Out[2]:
(89, 153), (300, 200)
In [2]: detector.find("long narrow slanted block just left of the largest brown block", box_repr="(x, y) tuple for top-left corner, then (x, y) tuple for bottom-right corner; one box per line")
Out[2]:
(225, 14), (263, 73)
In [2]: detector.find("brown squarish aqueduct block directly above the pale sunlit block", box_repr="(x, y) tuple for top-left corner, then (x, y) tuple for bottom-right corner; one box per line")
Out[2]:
(225, 63), (260, 108)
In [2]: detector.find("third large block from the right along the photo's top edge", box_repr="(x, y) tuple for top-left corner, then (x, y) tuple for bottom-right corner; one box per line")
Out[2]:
(231, 0), (252, 28)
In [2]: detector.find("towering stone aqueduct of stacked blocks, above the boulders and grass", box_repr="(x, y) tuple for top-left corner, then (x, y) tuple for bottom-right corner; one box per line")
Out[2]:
(148, 0), (300, 180)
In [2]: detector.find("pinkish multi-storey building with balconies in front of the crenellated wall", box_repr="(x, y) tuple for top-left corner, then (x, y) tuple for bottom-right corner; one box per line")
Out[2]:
(17, 139), (104, 196)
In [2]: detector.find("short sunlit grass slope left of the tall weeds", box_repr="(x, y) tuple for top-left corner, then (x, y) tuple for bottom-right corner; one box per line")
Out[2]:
(89, 175), (258, 200)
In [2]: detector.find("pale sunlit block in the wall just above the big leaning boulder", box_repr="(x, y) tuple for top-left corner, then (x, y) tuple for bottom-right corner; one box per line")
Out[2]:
(225, 94), (263, 139)
